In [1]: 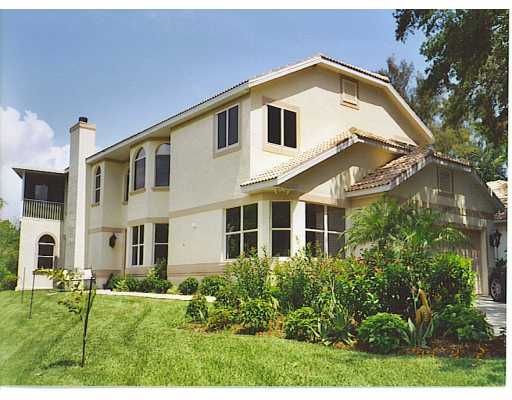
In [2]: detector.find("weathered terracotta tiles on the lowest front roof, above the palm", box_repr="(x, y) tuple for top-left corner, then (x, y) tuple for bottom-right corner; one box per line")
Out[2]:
(346, 146), (470, 192)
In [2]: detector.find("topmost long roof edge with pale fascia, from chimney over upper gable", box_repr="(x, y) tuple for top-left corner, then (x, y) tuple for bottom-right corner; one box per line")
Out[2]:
(87, 54), (434, 162)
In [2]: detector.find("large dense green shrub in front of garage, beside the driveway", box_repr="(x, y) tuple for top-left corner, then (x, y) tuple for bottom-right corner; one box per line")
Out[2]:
(426, 253), (476, 311)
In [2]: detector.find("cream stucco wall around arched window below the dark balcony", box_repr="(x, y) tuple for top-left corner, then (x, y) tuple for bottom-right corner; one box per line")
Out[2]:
(17, 217), (64, 289)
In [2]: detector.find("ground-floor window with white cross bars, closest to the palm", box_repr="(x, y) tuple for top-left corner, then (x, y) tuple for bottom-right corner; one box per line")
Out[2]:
(306, 203), (345, 256)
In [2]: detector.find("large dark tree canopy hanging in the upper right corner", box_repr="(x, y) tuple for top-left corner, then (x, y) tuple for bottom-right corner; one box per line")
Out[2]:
(394, 10), (508, 151)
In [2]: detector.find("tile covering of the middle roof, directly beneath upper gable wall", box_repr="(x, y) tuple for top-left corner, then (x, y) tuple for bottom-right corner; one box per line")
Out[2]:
(240, 128), (414, 186)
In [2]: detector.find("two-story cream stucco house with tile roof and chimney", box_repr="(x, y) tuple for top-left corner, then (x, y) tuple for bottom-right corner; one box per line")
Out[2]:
(16, 55), (502, 293)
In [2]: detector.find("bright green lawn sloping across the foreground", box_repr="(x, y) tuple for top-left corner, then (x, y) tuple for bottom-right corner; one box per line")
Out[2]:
(0, 292), (505, 386)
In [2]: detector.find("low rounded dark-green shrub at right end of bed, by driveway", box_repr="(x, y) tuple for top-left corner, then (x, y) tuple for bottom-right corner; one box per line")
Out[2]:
(435, 304), (493, 343)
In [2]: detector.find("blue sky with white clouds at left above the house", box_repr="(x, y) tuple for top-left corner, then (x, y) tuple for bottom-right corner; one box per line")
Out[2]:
(0, 10), (426, 219)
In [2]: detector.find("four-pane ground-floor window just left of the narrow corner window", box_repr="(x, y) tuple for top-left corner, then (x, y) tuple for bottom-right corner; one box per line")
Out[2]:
(226, 203), (258, 259)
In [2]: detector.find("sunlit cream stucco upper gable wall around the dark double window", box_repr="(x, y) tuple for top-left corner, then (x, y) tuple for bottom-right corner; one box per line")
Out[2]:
(250, 67), (426, 175)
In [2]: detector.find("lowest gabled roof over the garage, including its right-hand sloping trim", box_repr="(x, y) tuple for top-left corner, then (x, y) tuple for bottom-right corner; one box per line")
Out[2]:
(345, 146), (503, 208)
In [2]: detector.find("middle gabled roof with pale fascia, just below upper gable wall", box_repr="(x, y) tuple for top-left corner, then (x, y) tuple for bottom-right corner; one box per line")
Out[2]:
(240, 128), (414, 188)
